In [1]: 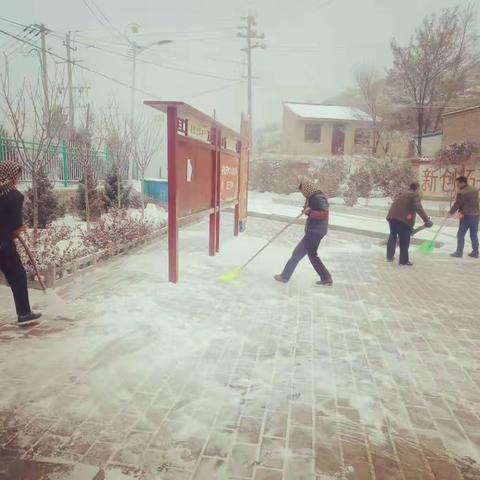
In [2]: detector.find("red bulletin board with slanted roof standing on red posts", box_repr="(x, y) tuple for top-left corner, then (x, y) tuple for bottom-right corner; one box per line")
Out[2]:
(144, 101), (248, 283)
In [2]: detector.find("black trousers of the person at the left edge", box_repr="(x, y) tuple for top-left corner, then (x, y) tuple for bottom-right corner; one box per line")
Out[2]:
(0, 245), (31, 315)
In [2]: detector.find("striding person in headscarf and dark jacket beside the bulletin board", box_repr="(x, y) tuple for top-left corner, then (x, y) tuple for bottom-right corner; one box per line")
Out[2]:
(274, 180), (333, 286)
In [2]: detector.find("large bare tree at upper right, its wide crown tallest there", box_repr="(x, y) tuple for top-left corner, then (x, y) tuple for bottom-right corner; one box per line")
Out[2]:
(390, 4), (478, 155)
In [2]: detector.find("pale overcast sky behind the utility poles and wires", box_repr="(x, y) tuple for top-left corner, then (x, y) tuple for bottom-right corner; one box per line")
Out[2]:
(0, 0), (474, 132)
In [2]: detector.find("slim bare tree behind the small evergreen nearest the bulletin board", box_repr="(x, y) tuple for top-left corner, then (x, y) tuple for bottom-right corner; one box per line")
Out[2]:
(104, 100), (133, 208)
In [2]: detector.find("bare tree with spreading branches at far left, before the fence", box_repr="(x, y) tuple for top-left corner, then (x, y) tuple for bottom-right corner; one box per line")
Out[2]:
(0, 58), (66, 231)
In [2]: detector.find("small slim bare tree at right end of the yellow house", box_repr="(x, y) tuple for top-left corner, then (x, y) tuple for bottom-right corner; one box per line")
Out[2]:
(355, 67), (383, 155)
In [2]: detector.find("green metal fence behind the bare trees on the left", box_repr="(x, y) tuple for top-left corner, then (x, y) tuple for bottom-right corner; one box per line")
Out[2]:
(0, 131), (139, 187)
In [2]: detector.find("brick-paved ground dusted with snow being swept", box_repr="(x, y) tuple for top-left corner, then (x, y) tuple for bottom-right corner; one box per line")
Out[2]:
(0, 219), (480, 480)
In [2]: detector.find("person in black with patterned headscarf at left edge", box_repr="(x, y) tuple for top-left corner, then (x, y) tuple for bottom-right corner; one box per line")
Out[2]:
(0, 161), (41, 325)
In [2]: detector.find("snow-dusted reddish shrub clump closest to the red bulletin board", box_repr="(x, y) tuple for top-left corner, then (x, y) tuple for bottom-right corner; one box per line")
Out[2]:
(80, 208), (158, 256)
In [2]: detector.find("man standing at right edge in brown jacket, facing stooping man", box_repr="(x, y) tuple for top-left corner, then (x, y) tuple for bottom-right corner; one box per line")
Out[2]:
(450, 176), (480, 258)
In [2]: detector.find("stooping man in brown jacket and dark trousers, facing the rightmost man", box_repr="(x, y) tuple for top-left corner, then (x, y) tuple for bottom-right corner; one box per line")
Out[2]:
(387, 182), (433, 266)
